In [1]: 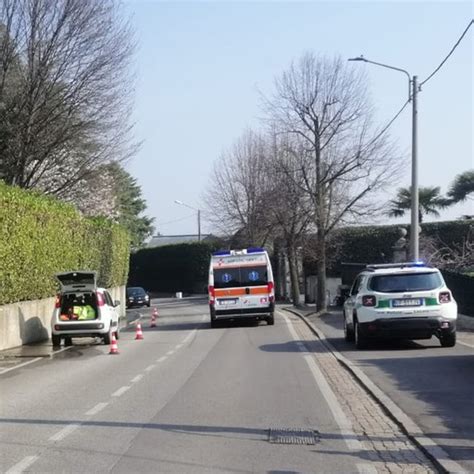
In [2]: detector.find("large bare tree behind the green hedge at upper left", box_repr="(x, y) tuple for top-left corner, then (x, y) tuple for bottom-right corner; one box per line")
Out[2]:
(0, 0), (136, 199)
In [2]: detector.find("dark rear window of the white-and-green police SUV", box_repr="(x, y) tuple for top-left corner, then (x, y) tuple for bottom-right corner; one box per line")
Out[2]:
(368, 272), (443, 293)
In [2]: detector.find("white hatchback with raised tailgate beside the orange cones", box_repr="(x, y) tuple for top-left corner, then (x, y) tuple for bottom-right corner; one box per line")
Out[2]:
(51, 271), (120, 346)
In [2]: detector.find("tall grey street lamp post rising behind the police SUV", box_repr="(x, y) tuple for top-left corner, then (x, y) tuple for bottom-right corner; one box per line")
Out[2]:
(349, 56), (419, 260)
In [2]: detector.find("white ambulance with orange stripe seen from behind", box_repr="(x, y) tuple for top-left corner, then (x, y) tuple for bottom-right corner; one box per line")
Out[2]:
(209, 247), (275, 327)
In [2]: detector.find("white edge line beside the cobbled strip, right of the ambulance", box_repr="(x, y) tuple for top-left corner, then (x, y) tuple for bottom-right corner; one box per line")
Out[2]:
(283, 315), (364, 451)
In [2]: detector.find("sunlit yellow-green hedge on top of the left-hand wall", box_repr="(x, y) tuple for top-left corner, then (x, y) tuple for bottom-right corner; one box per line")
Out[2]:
(0, 183), (130, 304)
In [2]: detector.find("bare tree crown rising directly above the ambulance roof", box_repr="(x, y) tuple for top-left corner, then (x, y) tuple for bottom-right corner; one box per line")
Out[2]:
(204, 130), (271, 245)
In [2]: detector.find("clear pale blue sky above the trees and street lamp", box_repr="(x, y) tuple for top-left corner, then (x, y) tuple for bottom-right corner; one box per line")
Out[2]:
(125, 0), (474, 235)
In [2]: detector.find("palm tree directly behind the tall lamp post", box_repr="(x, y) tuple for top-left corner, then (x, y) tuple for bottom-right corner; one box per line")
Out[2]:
(387, 186), (452, 223)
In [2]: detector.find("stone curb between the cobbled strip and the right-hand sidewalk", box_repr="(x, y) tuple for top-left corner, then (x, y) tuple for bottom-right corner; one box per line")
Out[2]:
(282, 308), (468, 474)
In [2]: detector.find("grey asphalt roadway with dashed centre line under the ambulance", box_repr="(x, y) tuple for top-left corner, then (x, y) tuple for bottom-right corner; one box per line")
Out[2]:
(0, 300), (374, 474)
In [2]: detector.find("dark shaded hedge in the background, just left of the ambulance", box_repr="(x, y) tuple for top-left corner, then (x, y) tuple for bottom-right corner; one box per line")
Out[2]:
(128, 242), (218, 293)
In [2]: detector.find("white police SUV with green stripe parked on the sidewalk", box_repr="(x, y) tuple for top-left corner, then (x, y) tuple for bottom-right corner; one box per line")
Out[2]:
(344, 263), (458, 349)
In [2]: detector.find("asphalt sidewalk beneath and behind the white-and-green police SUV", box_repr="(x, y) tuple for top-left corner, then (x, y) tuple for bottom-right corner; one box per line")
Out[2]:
(310, 312), (474, 472)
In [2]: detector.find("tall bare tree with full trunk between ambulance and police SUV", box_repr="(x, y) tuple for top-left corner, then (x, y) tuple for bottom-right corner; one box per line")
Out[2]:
(263, 53), (401, 310)
